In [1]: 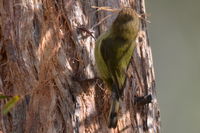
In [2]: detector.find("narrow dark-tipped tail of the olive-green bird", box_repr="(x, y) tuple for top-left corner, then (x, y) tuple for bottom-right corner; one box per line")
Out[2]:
(108, 93), (119, 128)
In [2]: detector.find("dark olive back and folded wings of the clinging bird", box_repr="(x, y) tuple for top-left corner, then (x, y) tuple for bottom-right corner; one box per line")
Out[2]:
(100, 37), (134, 97)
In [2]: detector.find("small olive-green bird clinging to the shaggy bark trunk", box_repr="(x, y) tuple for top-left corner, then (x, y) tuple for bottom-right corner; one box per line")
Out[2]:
(95, 8), (140, 128)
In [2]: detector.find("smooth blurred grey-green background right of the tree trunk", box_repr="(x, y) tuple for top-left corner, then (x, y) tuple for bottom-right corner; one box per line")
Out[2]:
(146, 0), (200, 133)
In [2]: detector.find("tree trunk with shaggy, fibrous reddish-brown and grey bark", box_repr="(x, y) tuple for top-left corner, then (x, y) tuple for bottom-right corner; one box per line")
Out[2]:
(0, 0), (160, 133)
